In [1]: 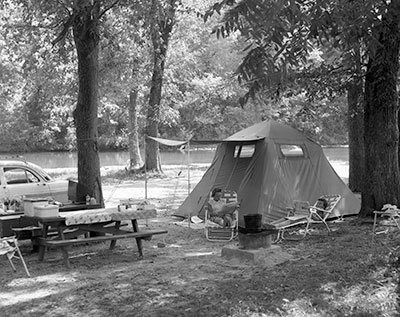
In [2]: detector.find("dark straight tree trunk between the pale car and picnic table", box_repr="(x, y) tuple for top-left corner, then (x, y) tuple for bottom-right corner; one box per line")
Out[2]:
(73, 0), (104, 206)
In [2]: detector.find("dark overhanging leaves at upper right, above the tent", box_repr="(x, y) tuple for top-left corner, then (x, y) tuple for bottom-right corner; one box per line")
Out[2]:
(204, 0), (386, 102)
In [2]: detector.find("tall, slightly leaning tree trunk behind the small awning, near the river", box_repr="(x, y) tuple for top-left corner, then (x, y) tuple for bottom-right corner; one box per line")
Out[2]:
(145, 0), (175, 172)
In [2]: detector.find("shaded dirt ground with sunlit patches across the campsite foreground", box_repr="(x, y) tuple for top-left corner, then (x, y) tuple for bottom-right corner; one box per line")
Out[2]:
(0, 167), (400, 317)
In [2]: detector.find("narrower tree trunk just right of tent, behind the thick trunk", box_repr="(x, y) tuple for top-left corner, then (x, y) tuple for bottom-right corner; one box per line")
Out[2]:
(347, 78), (365, 193)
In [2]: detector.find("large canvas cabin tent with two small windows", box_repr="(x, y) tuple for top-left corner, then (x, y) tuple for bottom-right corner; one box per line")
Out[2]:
(175, 120), (360, 225)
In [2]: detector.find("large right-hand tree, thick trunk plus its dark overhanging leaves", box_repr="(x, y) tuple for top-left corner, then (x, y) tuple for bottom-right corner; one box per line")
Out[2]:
(205, 0), (400, 215)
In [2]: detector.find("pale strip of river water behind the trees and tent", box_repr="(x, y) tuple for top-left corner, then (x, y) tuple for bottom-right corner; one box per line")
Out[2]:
(0, 147), (349, 178)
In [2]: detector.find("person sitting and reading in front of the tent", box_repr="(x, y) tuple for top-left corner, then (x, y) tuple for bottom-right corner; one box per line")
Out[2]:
(208, 188), (239, 227)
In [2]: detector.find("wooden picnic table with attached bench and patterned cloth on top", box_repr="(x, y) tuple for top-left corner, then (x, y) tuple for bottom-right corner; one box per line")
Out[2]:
(23, 207), (167, 268)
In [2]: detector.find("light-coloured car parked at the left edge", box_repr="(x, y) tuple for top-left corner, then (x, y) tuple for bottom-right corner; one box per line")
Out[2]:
(0, 159), (69, 204)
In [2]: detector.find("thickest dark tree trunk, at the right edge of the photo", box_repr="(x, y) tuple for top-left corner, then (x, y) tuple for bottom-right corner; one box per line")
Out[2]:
(360, 1), (400, 216)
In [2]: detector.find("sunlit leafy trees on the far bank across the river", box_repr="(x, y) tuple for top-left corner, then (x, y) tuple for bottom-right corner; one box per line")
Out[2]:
(0, 0), (350, 152)
